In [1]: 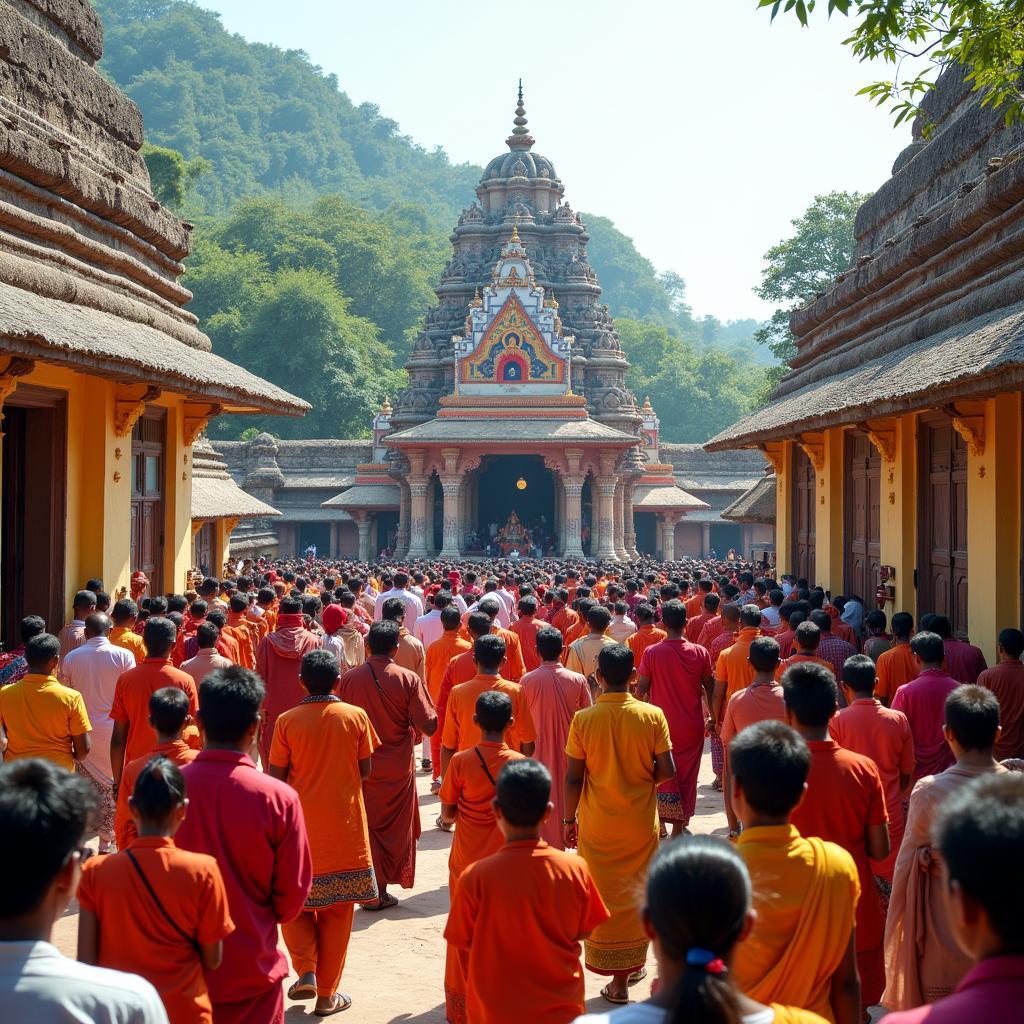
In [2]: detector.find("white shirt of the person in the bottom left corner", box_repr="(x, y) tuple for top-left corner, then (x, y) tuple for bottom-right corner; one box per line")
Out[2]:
(0, 941), (168, 1024)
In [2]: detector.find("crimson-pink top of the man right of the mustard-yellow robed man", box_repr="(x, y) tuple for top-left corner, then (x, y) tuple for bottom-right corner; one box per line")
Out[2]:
(640, 638), (711, 750)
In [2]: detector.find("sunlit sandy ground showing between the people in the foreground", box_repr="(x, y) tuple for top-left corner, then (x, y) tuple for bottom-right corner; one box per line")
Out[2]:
(53, 750), (726, 1024)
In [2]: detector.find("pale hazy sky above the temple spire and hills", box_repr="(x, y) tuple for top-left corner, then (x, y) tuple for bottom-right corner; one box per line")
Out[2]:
(192, 0), (909, 319)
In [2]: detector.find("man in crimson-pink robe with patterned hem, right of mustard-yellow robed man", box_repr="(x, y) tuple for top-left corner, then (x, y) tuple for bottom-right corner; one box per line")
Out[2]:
(637, 600), (712, 836)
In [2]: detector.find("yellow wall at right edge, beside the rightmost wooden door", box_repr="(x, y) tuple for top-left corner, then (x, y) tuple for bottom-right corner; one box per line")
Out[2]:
(967, 394), (1021, 664)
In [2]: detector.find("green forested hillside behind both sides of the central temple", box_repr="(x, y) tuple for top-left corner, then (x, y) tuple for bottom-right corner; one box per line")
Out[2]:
(94, 0), (772, 442)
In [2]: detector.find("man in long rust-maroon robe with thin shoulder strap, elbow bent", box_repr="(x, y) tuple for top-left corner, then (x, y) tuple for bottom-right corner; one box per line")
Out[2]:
(339, 621), (437, 910)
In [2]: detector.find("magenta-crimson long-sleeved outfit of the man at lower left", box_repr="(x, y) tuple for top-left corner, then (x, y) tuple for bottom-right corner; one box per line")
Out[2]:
(174, 751), (312, 1005)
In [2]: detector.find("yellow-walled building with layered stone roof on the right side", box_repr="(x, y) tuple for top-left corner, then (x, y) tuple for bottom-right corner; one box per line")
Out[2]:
(707, 68), (1024, 659)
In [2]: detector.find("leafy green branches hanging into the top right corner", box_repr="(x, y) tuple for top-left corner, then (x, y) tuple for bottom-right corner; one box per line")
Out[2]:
(758, 0), (1024, 134)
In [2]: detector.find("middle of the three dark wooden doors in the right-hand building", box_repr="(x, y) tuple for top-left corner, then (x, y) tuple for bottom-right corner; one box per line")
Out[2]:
(843, 431), (882, 607)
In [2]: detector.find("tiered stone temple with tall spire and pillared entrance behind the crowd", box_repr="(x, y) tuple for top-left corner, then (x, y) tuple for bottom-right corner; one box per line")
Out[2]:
(307, 87), (763, 561)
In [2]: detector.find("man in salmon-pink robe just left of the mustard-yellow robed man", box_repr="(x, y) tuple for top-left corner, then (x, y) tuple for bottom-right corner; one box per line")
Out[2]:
(519, 626), (593, 850)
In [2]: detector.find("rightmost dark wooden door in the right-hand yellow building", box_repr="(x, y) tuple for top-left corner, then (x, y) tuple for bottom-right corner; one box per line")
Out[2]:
(918, 418), (968, 634)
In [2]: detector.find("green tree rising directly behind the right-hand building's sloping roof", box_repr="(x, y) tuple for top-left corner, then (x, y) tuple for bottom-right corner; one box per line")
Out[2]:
(754, 191), (869, 401)
